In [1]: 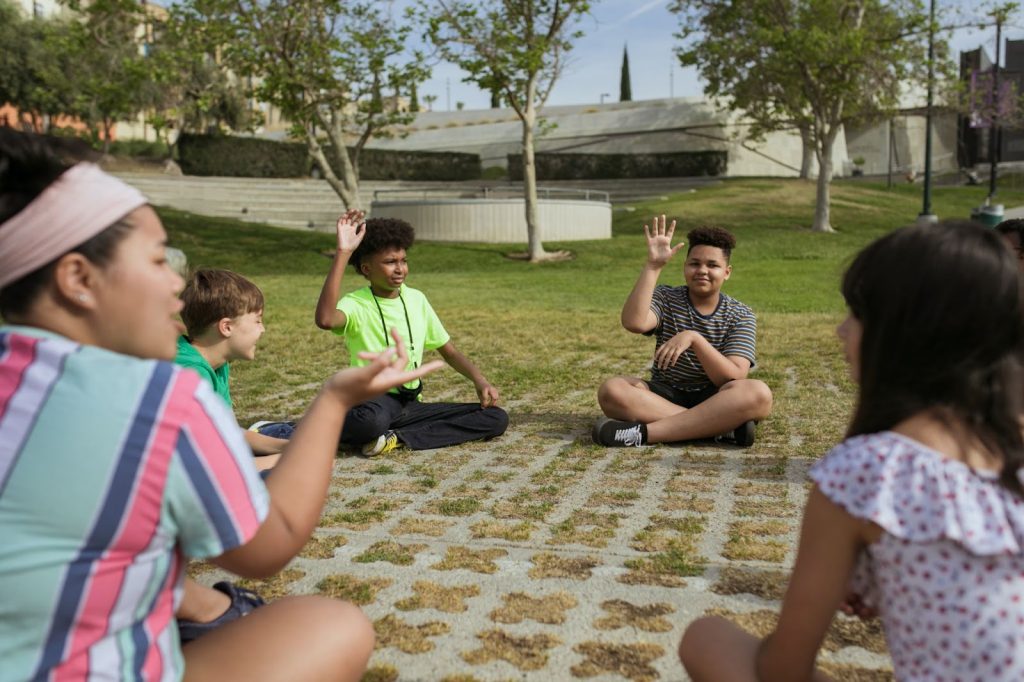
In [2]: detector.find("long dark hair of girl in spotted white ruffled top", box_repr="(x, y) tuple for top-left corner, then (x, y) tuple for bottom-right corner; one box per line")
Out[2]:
(843, 221), (1024, 495)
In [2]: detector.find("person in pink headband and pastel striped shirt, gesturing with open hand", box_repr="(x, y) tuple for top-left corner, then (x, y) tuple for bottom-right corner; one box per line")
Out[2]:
(0, 128), (440, 680)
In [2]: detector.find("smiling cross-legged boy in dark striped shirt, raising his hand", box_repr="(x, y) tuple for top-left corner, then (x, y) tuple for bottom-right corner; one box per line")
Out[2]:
(592, 215), (772, 446)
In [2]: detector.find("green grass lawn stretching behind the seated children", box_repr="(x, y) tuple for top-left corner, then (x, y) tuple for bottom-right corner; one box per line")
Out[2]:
(161, 179), (1024, 457)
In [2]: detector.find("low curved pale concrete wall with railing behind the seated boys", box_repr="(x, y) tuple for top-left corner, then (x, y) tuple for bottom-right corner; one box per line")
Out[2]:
(370, 199), (611, 244)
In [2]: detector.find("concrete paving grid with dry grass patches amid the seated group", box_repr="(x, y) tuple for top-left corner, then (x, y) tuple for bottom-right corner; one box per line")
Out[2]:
(193, 415), (892, 682)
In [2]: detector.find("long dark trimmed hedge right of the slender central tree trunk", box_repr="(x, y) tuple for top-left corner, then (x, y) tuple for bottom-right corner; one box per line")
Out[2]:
(508, 152), (728, 180)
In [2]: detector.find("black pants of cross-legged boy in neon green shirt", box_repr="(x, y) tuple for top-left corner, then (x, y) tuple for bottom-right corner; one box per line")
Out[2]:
(341, 393), (509, 450)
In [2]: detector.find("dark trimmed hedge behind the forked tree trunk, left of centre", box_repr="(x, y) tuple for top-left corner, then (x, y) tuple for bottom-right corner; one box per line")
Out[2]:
(178, 134), (480, 180)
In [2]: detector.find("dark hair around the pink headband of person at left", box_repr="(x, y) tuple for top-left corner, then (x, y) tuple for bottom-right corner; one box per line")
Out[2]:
(0, 126), (131, 318)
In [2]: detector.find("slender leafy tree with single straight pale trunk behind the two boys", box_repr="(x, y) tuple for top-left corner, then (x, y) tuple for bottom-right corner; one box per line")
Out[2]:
(420, 0), (590, 261)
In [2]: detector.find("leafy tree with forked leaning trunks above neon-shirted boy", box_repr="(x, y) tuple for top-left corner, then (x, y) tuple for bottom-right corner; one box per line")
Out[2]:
(182, 0), (427, 208)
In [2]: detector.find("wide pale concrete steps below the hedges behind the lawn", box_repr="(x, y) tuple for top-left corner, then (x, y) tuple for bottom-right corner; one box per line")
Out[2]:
(118, 173), (717, 231)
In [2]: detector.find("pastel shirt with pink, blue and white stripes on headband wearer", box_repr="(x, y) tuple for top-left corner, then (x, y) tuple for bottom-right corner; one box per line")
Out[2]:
(0, 327), (268, 680)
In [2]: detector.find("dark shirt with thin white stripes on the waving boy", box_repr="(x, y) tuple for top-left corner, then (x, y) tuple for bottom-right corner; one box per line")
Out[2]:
(648, 285), (758, 390)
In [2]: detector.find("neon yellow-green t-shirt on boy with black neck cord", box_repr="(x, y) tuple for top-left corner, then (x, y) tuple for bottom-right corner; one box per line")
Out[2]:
(334, 285), (450, 388)
